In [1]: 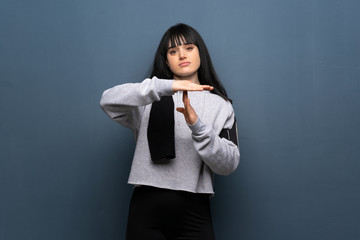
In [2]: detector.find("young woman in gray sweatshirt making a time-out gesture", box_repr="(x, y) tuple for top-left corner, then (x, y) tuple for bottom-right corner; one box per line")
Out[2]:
(100, 24), (240, 240)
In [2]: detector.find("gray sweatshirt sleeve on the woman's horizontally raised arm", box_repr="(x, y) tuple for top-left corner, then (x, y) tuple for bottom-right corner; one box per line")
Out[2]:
(100, 77), (173, 130)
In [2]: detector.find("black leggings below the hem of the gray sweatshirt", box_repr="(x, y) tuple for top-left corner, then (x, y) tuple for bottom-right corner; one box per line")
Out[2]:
(126, 186), (215, 240)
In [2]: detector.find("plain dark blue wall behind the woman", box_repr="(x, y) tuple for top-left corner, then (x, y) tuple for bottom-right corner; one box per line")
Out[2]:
(0, 0), (360, 240)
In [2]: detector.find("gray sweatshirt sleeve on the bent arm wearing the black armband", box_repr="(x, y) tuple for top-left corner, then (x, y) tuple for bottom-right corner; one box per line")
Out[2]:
(189, 106), (240, 175)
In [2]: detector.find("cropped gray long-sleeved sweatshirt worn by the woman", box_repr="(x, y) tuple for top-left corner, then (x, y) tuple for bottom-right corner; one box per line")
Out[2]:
(100, 77), (240, 194)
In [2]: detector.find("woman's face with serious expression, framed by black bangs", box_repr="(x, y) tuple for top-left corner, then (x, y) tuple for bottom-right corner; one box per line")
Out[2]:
(166, 41), (200, 83)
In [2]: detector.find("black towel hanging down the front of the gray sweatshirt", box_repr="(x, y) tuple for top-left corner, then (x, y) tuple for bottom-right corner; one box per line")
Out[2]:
(147, 96), (175, 162)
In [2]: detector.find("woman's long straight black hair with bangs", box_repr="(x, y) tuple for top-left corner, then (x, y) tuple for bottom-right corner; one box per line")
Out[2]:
(151, 23), (231, 102)
